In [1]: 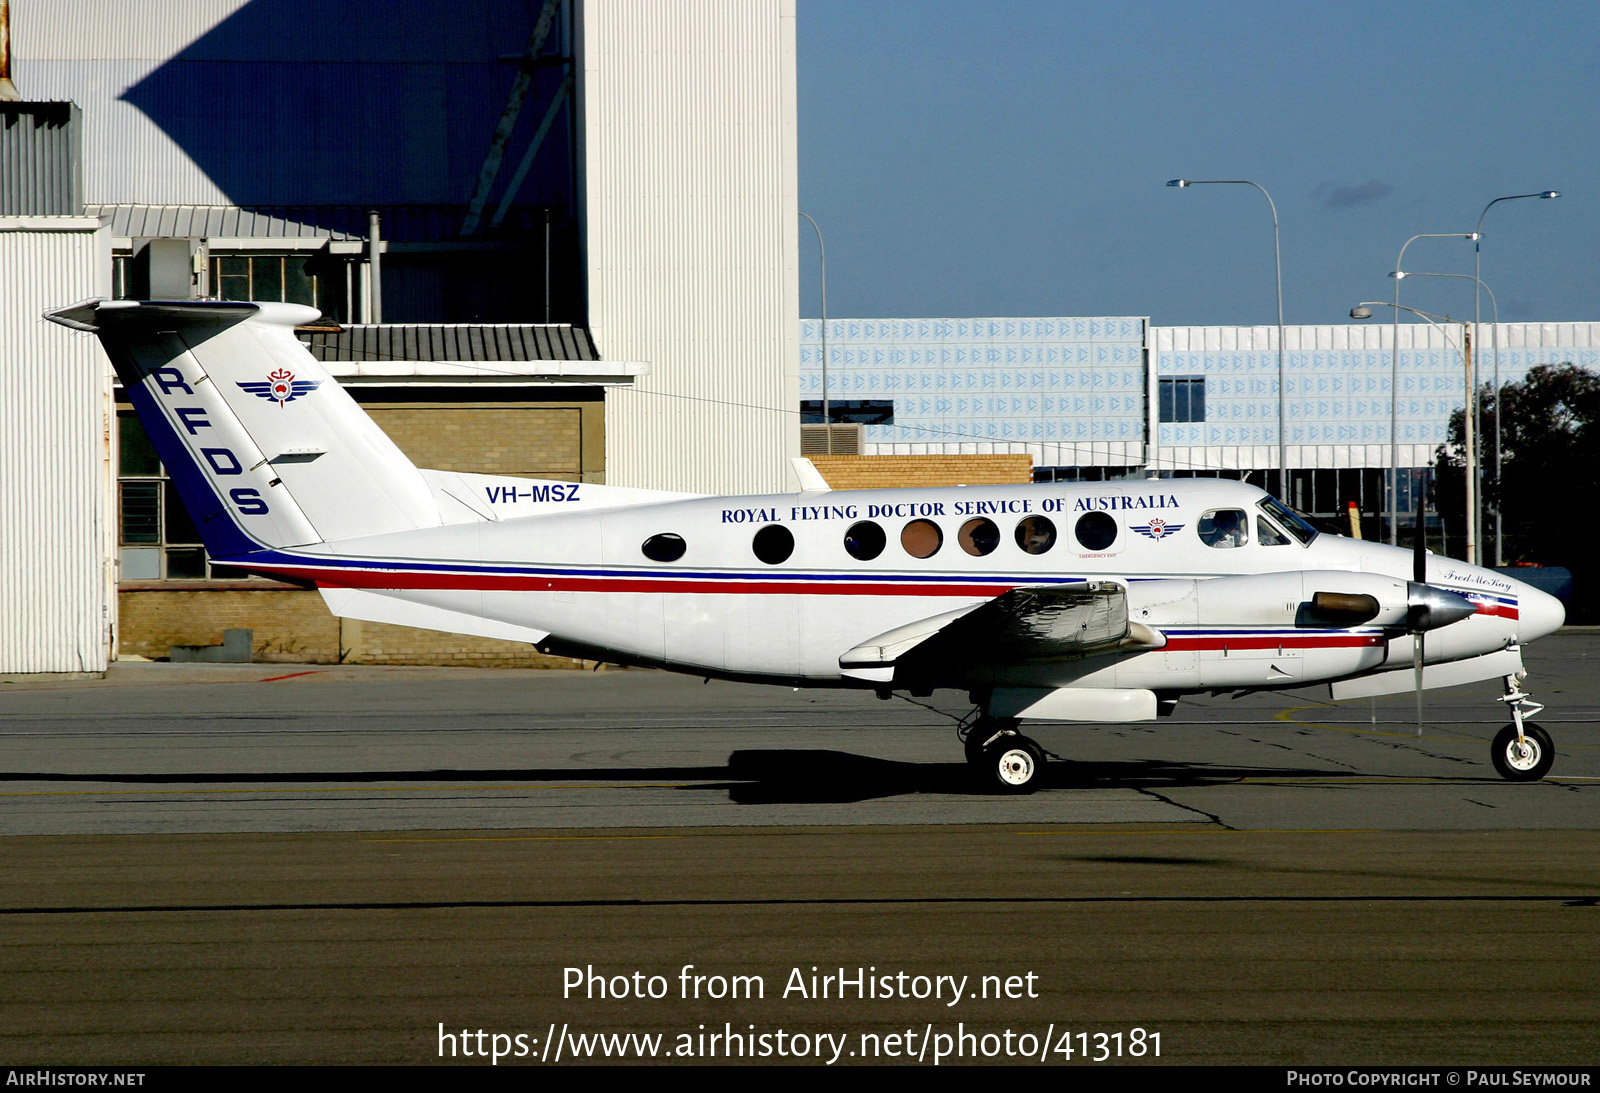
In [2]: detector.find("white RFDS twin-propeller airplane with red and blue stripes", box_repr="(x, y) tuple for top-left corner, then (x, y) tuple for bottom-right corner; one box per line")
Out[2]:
(45, 299), (1565, 794)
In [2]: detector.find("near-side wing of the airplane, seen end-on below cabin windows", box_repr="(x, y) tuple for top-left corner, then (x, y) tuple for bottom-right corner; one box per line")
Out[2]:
(838, 581), (1166, 682)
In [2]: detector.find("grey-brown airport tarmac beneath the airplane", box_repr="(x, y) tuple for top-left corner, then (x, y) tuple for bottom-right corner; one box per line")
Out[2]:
(0, 631), (1600, 1066)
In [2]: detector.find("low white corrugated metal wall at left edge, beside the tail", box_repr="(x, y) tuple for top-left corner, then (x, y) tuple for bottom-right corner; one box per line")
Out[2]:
(0, 216), (114, 672)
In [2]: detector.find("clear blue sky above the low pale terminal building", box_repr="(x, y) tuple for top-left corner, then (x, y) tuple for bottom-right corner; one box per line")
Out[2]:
(798, 0), (1600, 325)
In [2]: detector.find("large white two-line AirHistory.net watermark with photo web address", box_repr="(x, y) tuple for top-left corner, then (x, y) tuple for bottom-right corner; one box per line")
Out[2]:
(438, 963), (1162, 1066)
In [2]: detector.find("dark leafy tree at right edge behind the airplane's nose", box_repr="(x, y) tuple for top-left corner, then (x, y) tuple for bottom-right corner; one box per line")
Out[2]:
(1434, 362), (1600, 576)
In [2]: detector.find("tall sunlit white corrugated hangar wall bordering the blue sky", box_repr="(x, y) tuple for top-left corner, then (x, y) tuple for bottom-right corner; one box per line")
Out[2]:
(578, 0), (800, 493)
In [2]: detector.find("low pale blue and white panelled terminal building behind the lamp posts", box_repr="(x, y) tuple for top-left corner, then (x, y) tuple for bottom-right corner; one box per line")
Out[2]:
(800, 317), (1600, 554)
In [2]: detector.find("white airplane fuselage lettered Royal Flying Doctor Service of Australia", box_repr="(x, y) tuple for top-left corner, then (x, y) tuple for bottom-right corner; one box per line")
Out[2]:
(243, 480), (1560, 691)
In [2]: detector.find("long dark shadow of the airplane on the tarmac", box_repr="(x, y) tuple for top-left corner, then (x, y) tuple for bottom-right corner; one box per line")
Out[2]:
(0, 749), (1368, 805)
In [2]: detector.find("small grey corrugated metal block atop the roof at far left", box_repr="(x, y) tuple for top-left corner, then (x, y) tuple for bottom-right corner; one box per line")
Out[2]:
(0, 102), (83, 216)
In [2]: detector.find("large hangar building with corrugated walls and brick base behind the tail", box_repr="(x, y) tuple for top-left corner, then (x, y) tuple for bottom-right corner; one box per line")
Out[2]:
(0, 0), (798, 672)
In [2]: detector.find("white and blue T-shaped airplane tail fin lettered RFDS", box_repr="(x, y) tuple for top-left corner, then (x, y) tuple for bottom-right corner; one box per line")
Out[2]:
(45, 299), (440, 559)
